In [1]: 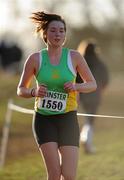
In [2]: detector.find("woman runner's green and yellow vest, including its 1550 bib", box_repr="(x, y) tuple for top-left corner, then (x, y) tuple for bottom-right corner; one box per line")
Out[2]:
(35, 48), (77, 115)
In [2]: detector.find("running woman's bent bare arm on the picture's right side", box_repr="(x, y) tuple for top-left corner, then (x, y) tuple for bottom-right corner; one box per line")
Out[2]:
(64, 51), (97, 93)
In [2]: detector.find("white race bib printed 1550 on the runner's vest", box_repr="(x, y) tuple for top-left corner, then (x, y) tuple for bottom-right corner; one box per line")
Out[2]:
(38, 91), (68, 112)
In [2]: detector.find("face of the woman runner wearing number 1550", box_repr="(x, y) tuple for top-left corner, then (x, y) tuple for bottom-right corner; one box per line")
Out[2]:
(47, 21), (66, 47)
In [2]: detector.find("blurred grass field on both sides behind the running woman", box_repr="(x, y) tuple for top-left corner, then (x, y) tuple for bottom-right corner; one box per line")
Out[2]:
(0, 71), (124, 180)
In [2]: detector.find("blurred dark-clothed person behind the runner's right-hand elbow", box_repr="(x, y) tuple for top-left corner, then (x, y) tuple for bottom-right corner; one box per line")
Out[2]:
(76, 40), (109, 153)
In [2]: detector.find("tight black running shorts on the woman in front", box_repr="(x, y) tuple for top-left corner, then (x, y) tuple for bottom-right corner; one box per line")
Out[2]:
(33, 111), (79, 147)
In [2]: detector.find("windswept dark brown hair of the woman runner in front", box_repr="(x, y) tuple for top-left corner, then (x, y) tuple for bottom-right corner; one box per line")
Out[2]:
(30, 11), (66, 42)
